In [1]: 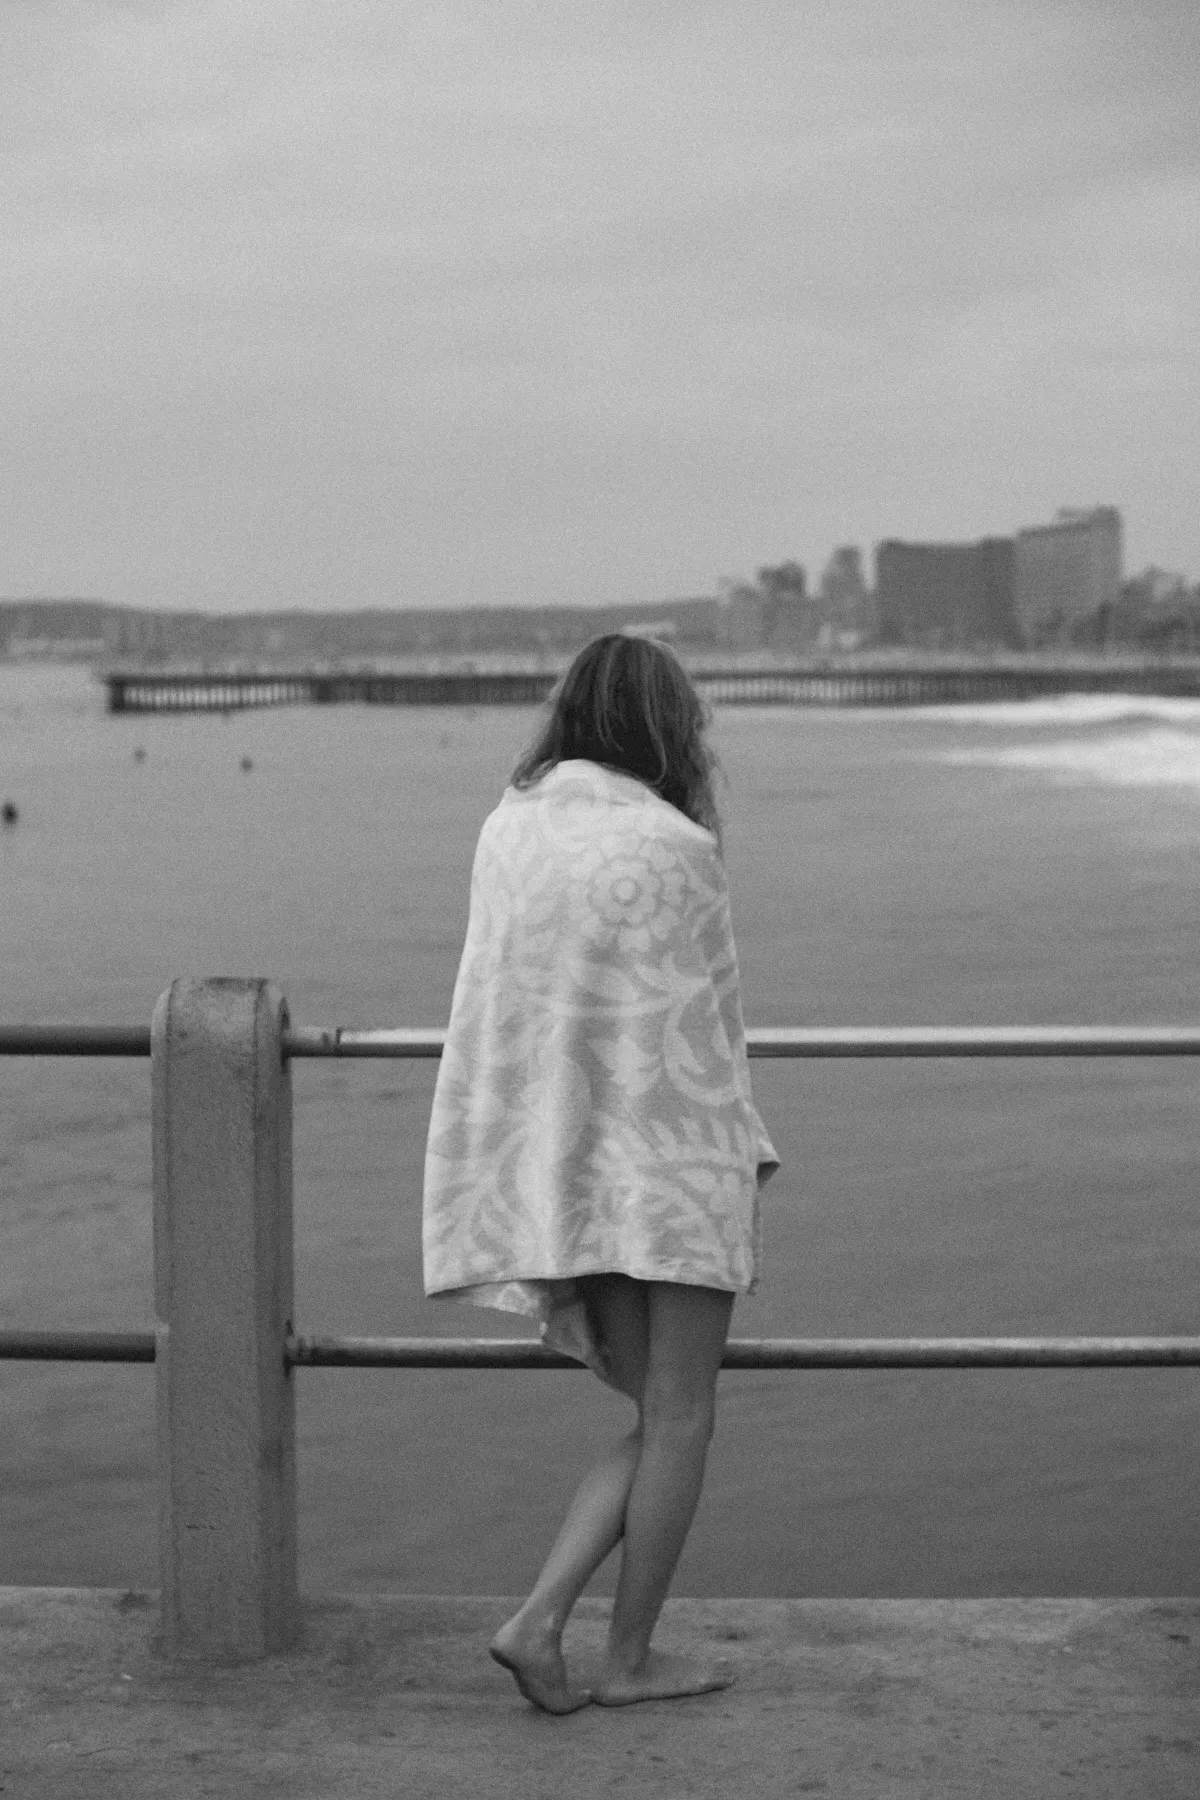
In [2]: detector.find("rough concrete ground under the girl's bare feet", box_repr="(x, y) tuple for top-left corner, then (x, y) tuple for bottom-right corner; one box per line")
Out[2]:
(0, 1588), (1200, 1800)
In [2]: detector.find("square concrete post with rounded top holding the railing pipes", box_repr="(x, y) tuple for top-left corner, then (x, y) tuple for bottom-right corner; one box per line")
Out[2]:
(151, 979), (299, 1660)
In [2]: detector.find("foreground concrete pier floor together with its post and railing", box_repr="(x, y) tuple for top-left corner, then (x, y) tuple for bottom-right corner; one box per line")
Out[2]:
(0, 979), (1200, 1800)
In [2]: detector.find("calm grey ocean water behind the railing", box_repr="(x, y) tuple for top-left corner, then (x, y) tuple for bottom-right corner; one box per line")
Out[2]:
(0, 668), (1200, 1595)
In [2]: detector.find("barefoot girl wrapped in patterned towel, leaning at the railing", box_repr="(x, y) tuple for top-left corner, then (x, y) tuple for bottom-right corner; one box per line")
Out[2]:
(425, 635), (779, 1712)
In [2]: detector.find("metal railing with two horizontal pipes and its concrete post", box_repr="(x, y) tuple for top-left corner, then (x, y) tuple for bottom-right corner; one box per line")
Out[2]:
(0, 979), (1200, 1660)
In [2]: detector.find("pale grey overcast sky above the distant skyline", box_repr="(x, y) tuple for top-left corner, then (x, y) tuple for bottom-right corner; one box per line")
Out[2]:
(0, 0), (1200, 608)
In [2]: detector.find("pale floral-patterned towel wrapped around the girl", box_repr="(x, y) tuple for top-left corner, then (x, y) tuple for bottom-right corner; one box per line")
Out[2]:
(425, 761), (779, 1375)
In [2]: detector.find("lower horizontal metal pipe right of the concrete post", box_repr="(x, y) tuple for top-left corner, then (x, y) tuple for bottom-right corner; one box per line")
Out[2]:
(288, 1337), (1200, 1370)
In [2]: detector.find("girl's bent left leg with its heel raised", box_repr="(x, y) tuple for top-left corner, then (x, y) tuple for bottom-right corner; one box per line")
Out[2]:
(491, 1276), (648, 1712)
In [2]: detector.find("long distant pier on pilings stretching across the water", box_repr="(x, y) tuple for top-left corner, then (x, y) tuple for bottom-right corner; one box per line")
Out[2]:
(104, 659), (1200, 713)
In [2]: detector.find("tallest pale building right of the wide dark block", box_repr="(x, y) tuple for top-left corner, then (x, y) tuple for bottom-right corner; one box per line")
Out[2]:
(1015, 506), (1121, 644)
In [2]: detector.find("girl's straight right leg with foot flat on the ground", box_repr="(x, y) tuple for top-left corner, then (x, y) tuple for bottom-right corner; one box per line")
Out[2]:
(592, 1282), (734, 1706)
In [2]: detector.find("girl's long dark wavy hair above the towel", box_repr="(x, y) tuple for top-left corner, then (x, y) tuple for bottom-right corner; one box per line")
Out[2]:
(513, 632), (721, 844)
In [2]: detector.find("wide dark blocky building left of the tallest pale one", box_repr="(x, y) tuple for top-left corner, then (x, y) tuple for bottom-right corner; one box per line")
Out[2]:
(874, 538), (1016, 650)
